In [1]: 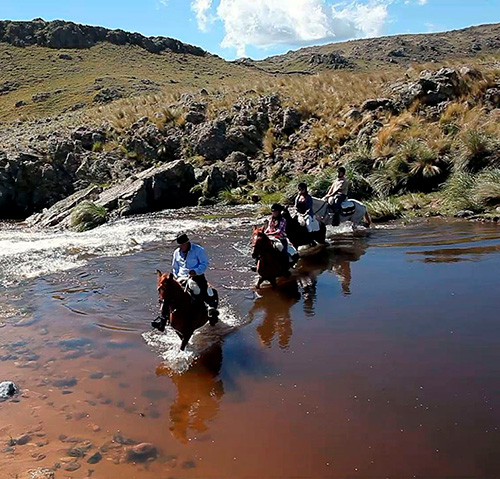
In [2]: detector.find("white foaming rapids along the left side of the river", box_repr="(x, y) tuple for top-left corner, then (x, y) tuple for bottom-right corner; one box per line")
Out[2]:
(0, 210), (256, 287)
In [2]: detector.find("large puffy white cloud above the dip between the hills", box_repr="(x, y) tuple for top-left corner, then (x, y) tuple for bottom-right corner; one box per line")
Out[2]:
(191, 0), (428, 56)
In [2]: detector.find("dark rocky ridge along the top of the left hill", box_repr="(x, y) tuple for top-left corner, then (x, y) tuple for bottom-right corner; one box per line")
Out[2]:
(0, 19), (207, 56)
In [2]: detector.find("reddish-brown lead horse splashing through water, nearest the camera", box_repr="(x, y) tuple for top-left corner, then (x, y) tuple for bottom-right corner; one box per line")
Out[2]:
(153, 271), (218, 351)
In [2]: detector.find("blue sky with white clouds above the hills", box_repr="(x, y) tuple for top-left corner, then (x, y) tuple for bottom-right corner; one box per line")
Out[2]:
(0, 0), (500, 59)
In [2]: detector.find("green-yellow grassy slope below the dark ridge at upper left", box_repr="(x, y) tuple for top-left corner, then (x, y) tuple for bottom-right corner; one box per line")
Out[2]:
(0, 43), (265, 121)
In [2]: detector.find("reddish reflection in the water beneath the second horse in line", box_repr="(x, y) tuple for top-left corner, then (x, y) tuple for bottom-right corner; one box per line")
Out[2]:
(248, 279), (301, 349)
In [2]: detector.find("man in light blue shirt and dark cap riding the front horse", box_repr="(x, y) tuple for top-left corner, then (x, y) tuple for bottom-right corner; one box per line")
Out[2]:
(172, 233), (219, 318)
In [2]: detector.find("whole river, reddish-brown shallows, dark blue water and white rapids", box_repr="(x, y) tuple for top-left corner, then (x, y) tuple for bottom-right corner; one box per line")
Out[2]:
(0, 208), (500, 479)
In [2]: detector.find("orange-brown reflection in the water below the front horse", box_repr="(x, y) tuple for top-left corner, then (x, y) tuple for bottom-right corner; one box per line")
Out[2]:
(156, 344), (224, 443)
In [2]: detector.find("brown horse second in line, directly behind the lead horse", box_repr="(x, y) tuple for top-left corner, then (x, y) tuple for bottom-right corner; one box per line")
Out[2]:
(252, 226), (290, 288)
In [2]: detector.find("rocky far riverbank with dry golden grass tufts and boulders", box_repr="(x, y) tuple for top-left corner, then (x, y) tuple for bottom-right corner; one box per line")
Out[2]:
(0, 58), (500, 229)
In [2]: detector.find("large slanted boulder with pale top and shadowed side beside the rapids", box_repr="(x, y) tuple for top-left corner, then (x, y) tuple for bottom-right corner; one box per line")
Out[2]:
(96, 160), (196, 215)
